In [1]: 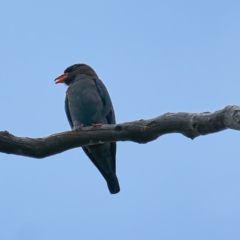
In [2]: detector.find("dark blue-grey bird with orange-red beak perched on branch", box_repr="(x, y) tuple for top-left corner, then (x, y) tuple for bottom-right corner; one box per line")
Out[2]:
(55, 63), (120, 194)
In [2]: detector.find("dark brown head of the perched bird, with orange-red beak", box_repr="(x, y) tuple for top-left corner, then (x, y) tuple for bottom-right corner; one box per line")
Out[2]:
(55, 63), (98, 85)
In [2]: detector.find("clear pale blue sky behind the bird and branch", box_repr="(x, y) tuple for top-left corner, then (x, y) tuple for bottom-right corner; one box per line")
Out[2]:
(0, 0), (240, 240)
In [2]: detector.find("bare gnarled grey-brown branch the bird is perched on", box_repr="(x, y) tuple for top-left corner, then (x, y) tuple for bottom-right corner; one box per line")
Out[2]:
(0, 105), (240, 158)
